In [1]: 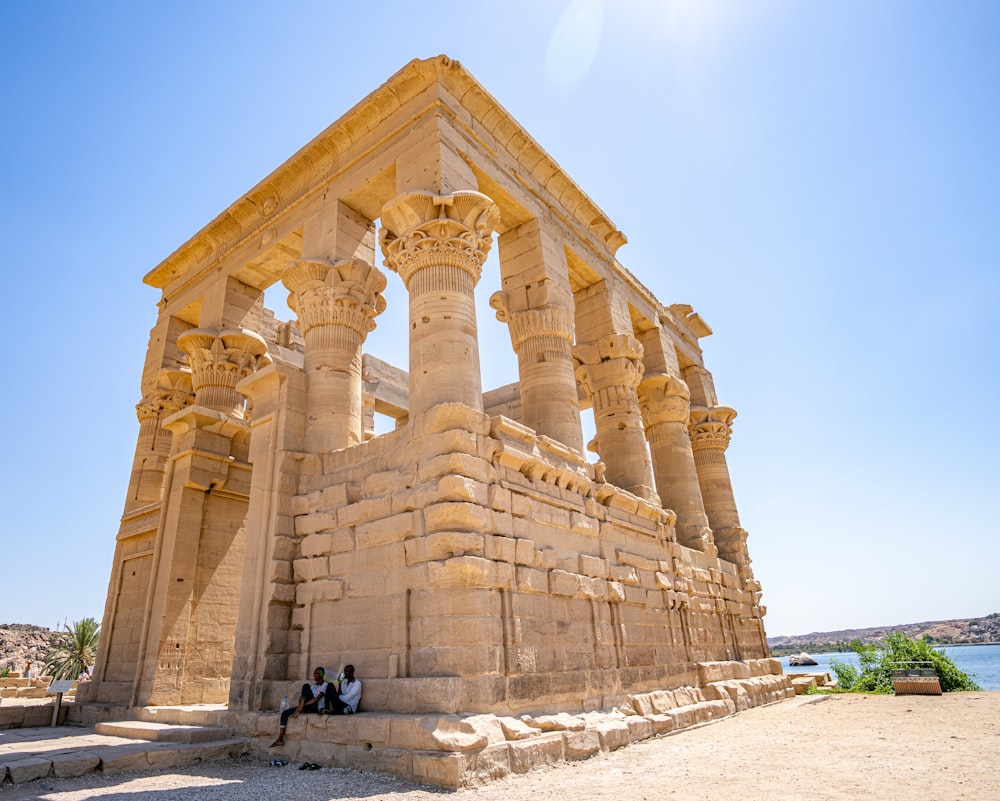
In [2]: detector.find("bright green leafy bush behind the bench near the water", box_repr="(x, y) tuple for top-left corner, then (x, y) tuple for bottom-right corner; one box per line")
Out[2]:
(830, 631), (980, 693)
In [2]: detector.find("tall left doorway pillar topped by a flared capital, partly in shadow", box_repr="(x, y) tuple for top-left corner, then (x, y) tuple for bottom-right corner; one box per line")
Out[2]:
(131, 328), (270, 705)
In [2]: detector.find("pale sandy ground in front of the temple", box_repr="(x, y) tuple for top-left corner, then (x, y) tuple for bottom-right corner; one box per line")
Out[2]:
(0, 692), (1000, 801)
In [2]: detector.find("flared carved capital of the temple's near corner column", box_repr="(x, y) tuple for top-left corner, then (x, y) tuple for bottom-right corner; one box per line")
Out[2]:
(379, 190), (500, 289)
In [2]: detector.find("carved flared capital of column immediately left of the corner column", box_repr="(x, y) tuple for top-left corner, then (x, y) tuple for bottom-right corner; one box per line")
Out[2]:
(281, 259), (386, 341)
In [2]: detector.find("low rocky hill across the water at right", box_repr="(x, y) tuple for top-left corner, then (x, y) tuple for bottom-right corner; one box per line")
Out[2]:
(767, 612), (1000, 656)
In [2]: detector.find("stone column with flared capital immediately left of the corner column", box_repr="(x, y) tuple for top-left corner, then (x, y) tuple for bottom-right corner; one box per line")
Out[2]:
(281, 259), (385, 453)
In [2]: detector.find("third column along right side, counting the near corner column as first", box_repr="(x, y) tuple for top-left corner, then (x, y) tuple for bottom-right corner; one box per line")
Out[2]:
(573, 334), (660, 503)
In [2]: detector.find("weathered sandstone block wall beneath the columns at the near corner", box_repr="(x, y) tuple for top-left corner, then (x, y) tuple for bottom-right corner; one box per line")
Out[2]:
(244, 406), (766, 713)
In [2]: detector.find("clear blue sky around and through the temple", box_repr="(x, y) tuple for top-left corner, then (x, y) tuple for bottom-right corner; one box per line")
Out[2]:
(0, 0), (1000, 635)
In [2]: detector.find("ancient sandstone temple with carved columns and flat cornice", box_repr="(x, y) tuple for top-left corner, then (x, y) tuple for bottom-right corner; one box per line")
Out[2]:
(89, 57), (787, 783)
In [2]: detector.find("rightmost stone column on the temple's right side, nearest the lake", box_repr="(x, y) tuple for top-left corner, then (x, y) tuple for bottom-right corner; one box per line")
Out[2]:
(689, 406), (750, 565)
